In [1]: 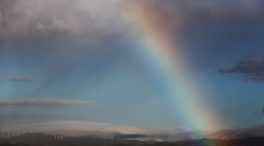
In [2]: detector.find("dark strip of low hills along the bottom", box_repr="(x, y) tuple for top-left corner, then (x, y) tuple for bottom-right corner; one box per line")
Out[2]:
(0, 134), (264, 146)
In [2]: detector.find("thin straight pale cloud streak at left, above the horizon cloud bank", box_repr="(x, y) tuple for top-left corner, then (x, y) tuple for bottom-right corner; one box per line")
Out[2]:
(0, 99), (95, 106)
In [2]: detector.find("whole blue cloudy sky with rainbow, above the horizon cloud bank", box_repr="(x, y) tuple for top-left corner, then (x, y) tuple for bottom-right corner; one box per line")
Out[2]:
(0, 0), (264, 130)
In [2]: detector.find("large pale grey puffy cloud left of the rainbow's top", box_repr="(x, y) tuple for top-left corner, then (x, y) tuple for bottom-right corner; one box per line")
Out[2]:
(0, 0), (127, 42)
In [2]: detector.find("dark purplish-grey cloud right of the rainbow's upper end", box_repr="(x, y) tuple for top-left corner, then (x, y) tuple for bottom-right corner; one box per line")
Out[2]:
(131, 0), (264, 41)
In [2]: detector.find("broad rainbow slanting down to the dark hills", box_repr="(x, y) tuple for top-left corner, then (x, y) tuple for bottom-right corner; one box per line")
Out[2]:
(124, 3), (227, 144)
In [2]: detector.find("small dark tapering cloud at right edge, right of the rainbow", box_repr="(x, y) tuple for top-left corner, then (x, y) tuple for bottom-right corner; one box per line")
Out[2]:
(220, 55), (264, 81)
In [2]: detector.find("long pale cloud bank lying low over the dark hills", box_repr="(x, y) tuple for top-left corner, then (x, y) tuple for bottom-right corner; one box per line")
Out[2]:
(0, 121), (191, 136)
